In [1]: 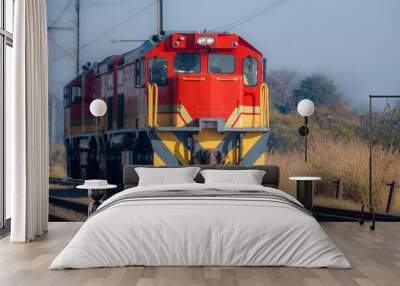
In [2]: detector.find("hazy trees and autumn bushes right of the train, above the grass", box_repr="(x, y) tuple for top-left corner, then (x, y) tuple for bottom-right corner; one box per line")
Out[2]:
(267, 70), (400, 152)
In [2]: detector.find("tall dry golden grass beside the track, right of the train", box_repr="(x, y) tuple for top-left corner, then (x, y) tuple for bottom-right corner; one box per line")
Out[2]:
(269, 138), (400, 212)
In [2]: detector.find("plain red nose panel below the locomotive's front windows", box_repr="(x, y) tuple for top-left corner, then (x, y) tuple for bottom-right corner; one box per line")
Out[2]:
(176, 74), (243, 124)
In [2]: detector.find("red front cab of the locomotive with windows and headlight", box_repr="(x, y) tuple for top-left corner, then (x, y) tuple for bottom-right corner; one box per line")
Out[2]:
(146, 33), (267, 128)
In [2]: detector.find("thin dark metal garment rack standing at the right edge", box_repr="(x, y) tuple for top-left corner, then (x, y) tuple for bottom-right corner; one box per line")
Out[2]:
(359, 95), (400, 230)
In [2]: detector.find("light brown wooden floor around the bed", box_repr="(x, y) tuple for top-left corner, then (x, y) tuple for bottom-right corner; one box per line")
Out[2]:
(0, 222), (400, 286)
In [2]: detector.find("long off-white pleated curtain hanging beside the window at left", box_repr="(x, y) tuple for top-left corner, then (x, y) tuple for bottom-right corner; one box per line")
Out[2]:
(6, 0), (49, 242)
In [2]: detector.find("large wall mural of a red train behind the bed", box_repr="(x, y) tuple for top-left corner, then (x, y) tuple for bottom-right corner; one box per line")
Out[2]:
(47, 0), (400, 221)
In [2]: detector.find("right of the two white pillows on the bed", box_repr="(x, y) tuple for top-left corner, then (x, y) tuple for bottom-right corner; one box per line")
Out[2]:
(200, 170), (265, 185)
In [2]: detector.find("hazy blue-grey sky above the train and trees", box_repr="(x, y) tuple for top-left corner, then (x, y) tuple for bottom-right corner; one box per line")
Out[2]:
(47, 0), (400, 108)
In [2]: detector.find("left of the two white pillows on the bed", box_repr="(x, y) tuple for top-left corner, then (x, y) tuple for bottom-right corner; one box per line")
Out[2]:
(135, 167), (200, 186)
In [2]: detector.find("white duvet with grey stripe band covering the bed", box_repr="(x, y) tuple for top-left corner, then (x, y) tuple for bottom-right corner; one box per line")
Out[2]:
(50, 184), (351, 269)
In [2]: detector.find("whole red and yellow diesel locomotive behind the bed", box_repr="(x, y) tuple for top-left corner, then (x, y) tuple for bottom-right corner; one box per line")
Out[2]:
(64, 32), (270, 182)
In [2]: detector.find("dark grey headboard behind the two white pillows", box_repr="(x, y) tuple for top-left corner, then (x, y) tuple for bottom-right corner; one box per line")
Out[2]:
(123, 165), (279, 189)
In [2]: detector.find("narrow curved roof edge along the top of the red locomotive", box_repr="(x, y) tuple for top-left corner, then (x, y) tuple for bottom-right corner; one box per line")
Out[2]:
(67, 31), (262, 85)
